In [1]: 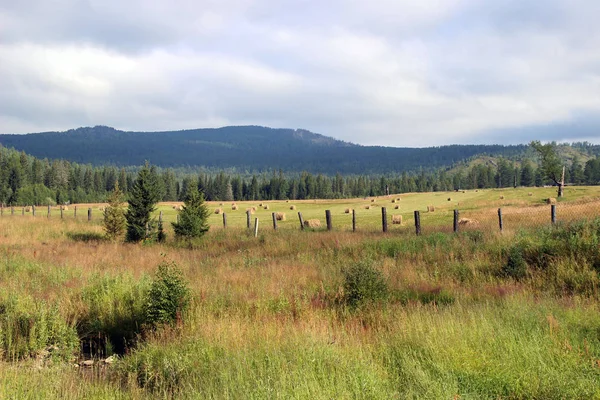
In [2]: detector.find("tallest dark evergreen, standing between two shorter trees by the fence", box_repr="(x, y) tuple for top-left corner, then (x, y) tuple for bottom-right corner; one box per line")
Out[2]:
(125, 163), (162, 242)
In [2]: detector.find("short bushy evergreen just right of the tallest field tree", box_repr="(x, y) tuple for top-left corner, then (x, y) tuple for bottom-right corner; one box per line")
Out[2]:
(172, 190), (210, 239)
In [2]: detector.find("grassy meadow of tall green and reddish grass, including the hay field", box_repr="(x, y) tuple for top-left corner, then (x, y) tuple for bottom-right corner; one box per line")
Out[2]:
(0, 187), (600, 399)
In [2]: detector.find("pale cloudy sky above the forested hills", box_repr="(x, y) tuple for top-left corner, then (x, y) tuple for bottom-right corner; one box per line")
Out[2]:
(0, 0), (600, 147)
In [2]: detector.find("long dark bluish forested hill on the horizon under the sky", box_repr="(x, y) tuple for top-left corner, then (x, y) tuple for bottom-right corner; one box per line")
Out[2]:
(0, 126), (526, 175)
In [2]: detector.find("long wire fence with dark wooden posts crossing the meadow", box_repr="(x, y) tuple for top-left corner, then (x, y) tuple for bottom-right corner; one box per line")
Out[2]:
(5, 200), (600, 236)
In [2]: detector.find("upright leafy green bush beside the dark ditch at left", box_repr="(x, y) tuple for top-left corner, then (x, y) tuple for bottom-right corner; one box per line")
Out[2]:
(146, 262), (190, 325)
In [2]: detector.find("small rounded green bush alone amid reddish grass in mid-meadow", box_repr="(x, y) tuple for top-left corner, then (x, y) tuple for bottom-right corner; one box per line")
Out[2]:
(343, 261), (389, 308)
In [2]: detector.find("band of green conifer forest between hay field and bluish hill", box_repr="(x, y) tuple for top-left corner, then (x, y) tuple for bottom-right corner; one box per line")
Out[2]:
(0, 147), (600, 205)
